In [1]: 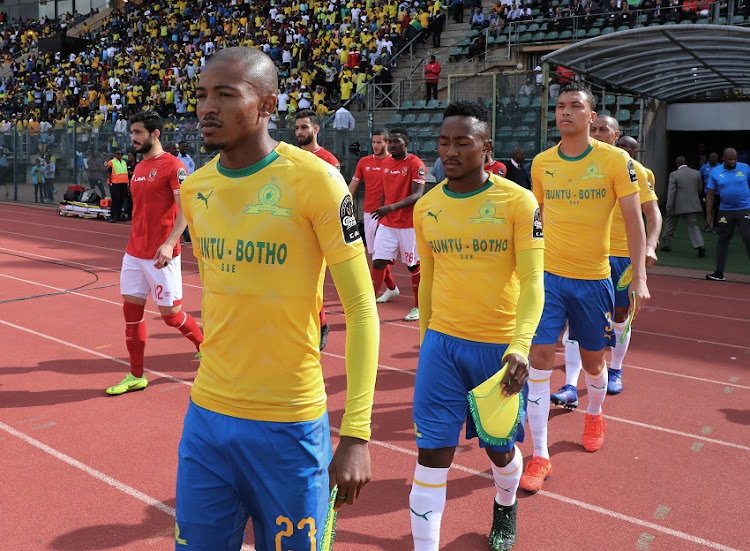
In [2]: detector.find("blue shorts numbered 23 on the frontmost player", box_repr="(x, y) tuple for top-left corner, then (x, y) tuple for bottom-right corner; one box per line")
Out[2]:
(175, 401), (331, 551)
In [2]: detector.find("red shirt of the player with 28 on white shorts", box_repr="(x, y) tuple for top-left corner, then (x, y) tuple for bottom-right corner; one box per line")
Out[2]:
(380, 153), (427, 228)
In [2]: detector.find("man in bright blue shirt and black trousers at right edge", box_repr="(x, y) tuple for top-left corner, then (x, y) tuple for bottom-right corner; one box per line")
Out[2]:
(706, 147), (750, 281)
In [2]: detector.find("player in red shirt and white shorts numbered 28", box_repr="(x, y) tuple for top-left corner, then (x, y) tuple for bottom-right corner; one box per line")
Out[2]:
(372, 128), (427, 321)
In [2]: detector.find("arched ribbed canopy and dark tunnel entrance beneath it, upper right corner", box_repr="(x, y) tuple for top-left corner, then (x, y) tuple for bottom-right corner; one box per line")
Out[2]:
(542, 24), (750, 198)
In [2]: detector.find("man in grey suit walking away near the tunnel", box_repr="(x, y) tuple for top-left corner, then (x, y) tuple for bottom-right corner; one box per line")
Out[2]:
(661, 156), (706, 257)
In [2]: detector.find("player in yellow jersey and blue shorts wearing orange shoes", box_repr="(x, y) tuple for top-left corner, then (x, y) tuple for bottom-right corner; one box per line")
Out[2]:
(521, 83), (649, 492)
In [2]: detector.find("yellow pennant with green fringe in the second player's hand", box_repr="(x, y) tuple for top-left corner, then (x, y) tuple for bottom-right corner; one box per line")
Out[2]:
(467, 363), (523, 446)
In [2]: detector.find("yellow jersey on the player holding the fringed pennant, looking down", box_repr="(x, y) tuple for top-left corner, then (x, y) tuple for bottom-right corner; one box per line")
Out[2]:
(414, 174), (544, 344)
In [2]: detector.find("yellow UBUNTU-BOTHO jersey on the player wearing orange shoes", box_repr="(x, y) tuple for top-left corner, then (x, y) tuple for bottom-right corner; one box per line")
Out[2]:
(531, 140), (638, 279)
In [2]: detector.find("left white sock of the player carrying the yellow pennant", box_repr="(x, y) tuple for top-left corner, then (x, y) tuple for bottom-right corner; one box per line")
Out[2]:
(409, 463), (448, 551)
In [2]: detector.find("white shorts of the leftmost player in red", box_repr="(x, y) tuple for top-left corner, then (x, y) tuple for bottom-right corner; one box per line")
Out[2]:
(120, 253), (182, 306)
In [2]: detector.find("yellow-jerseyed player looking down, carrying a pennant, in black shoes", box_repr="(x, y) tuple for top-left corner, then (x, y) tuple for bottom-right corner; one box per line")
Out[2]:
(409, 101), (544, 551)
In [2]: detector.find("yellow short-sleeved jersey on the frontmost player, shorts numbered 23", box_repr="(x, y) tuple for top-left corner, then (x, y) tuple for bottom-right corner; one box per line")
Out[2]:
(181, 143), (366, 422)
